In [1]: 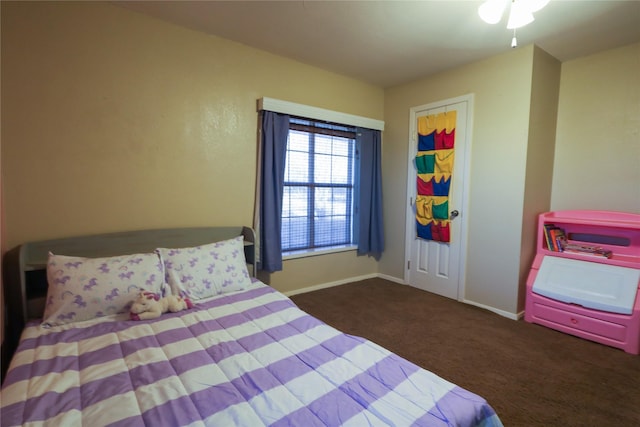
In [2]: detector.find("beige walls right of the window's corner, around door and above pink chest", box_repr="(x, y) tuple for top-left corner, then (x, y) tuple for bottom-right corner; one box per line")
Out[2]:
(380, 44), (640, 314)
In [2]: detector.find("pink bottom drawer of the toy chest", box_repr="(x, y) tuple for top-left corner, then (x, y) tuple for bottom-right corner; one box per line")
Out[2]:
(533, 303), (627, 342)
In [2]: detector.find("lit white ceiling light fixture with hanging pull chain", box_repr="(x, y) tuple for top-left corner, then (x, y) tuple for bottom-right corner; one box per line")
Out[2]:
(478, 0), (550, 47)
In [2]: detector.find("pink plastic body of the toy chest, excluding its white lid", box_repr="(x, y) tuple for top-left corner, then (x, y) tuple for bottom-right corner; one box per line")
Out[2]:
(525, 210), (640, 354)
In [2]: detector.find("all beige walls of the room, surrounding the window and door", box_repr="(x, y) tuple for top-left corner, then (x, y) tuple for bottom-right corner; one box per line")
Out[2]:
(1, 2), (640, 320)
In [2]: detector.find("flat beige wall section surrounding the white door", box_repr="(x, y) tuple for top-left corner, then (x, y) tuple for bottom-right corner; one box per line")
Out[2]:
(380, 46), (534, 313)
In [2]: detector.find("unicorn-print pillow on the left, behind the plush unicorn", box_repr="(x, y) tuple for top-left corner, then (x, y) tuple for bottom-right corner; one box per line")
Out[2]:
(42, 253), (166, 326)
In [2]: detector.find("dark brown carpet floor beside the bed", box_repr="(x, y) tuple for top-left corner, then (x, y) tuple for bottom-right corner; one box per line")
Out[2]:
(292, 279), (640, 427)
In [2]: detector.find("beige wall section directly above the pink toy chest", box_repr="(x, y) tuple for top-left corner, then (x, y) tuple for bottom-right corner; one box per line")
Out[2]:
(551, 43), (640, 213)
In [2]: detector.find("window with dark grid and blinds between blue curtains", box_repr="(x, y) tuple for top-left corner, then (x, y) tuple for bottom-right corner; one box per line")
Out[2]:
(282, 117), (356, 252)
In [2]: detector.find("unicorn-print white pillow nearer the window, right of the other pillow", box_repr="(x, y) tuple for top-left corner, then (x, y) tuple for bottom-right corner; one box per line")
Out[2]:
(156, 236), (251, 299)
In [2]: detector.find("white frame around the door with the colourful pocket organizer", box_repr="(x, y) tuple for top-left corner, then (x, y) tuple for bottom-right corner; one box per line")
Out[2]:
(403, 93), (474, 301)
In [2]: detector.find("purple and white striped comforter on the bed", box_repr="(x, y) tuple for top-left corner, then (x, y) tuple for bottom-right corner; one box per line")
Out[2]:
(2, 283), (502, 427)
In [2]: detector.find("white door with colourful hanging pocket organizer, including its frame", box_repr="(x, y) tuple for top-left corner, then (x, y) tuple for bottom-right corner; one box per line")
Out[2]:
(404, 95), (473, 300)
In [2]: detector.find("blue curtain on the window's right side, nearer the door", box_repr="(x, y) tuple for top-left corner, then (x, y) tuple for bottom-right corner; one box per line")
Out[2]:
(354, 128), (384, 259)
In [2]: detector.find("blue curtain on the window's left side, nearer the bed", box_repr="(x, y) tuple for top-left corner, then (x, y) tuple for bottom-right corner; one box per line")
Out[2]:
(260, 111), (289, 272)
